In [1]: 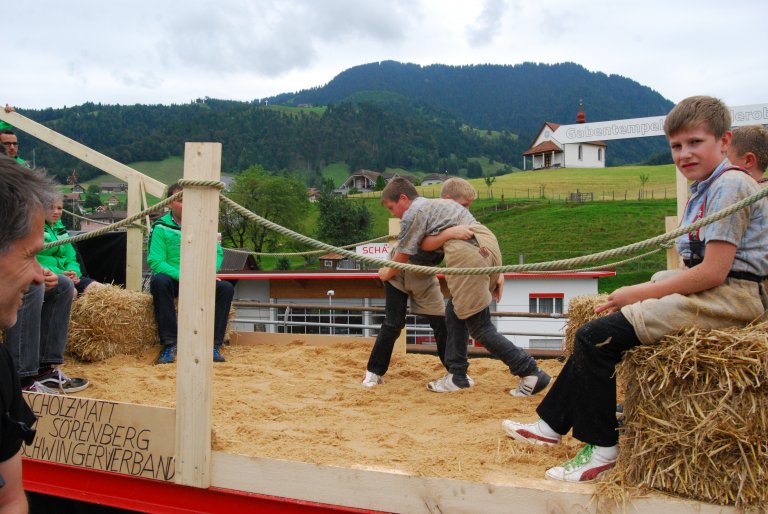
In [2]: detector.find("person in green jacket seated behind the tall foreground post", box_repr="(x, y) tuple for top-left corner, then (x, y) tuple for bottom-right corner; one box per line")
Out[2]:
(147, 183), (235, 364)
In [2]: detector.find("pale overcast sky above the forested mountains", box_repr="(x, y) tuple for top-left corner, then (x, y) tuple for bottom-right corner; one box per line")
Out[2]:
(6, 0), (768, 112)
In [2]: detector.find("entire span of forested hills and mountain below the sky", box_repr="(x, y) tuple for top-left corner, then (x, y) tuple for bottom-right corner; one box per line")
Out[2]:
(12, 61), (672, 185)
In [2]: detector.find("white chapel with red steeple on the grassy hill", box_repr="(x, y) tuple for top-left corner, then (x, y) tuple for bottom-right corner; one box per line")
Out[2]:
(523, 101), (608, 170)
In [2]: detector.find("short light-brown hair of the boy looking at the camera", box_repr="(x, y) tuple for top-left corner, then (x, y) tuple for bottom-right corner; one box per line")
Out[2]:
(664, 96), (731, 138)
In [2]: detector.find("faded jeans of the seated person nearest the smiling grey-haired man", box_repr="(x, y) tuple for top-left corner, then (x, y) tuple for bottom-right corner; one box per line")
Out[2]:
(5, 275), (75, 378)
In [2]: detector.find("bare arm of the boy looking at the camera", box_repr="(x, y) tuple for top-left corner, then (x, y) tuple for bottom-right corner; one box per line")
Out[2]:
(595, 241), (736, 314)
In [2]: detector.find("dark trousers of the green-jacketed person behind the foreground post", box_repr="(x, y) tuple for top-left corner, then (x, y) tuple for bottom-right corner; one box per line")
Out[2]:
(149, 273), (235, 344)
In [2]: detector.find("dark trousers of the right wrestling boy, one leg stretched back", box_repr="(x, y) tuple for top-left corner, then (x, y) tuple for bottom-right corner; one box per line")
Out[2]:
(445, 300), (537, 377)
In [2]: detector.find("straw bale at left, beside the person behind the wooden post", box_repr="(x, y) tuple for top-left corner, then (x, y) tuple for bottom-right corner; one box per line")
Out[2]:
(67, 285), (160, 362)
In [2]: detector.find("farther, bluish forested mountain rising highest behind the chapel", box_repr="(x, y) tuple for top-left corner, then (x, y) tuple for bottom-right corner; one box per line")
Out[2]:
(270, 61), (674, 165)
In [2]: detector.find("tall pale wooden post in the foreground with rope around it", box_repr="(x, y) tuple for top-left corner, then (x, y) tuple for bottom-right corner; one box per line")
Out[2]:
(176, 143), (221, 488)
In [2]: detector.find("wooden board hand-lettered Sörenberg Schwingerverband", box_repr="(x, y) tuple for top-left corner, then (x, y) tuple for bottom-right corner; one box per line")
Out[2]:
(22, 393), (176, 481)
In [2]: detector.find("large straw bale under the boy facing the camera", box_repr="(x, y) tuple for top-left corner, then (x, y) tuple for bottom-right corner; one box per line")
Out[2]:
(611, 322), (768, 511)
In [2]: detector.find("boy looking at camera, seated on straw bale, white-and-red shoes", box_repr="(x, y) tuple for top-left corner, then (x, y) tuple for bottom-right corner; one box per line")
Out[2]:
(503, 96), (768, 482)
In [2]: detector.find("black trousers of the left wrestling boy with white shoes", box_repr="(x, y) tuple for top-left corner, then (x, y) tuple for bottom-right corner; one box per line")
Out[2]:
(367, 282), (447, 375)
